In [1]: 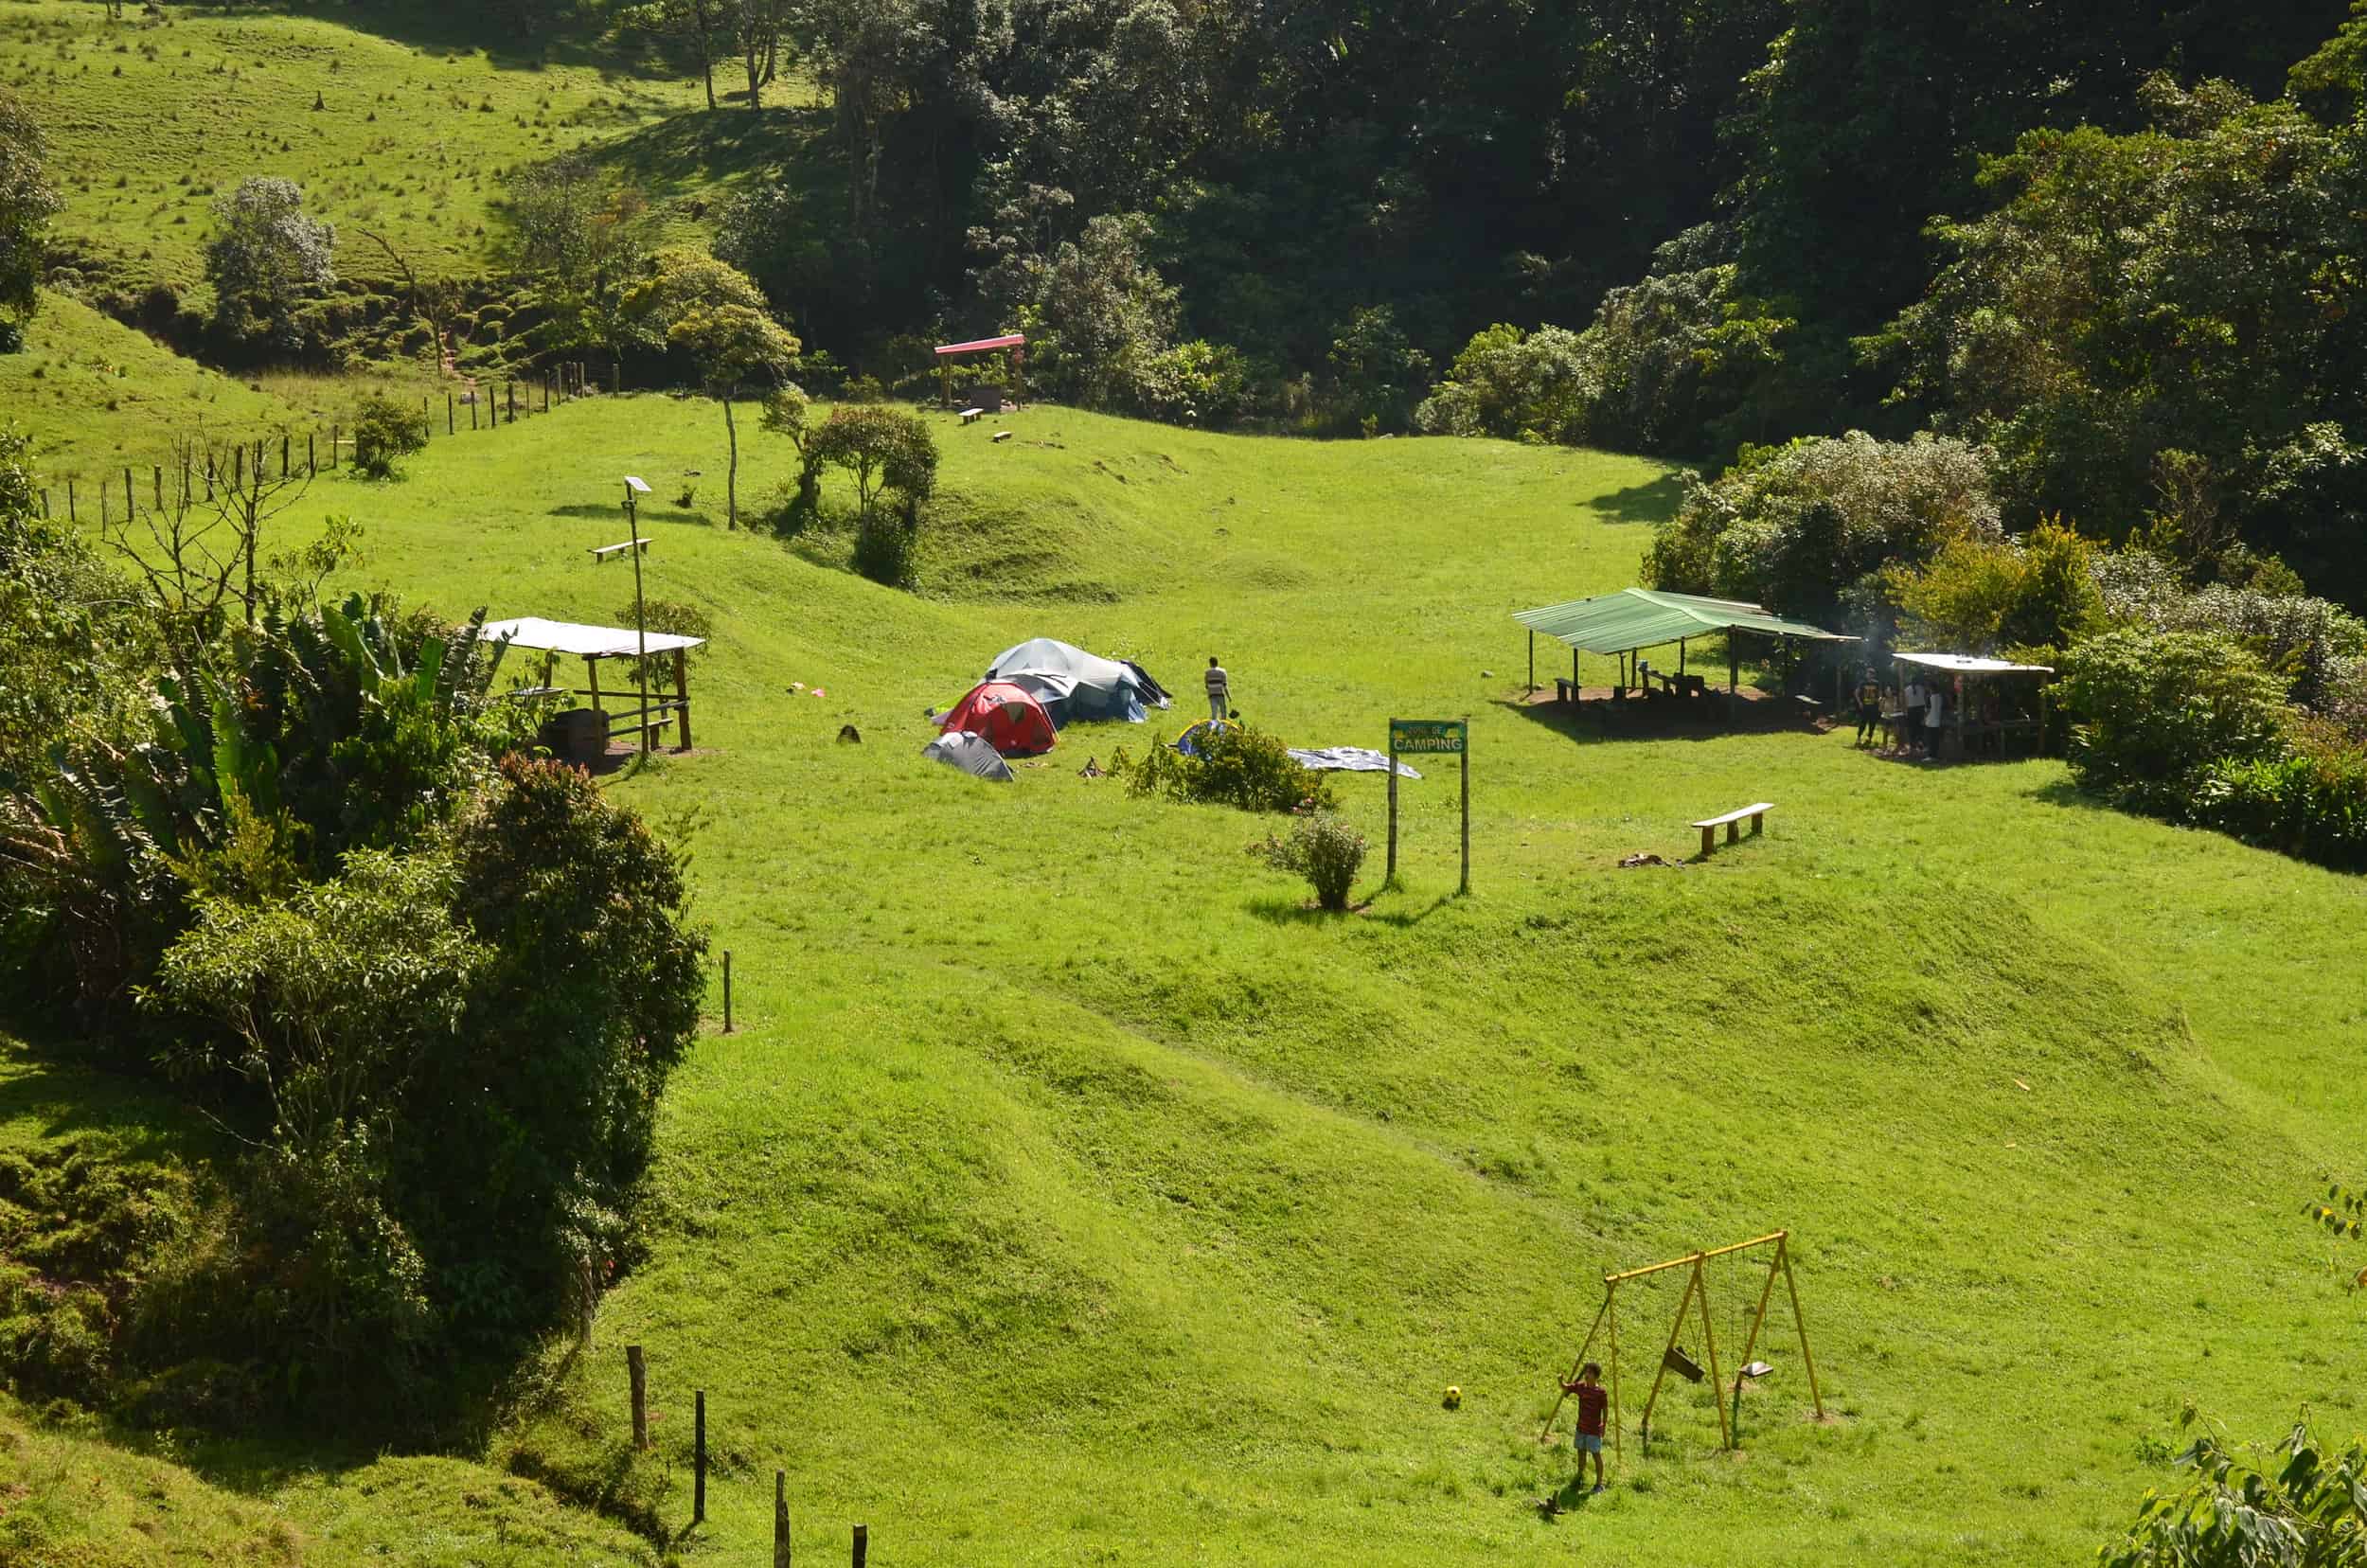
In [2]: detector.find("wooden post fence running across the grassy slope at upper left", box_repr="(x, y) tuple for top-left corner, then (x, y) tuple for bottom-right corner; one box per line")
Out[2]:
(41, 360), (615, 528)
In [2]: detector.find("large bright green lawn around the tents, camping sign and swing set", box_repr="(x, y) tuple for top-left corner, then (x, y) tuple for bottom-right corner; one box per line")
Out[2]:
(4, 396), (2367, 1565)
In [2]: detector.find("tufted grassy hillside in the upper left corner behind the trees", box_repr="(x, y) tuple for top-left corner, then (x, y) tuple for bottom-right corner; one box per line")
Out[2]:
(0, 0), (810, 292)
